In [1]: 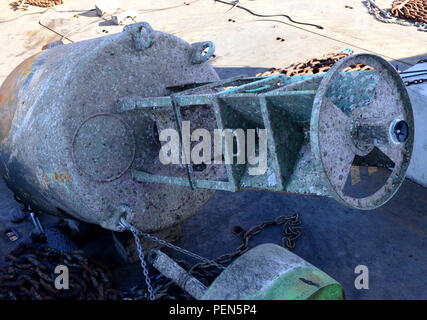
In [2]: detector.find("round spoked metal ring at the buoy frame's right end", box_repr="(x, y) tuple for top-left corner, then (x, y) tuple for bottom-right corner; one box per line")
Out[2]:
(310, 54), (414, 210)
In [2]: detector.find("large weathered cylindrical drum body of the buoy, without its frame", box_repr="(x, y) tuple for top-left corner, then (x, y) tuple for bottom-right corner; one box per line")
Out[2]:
(0, 23), (218, 231)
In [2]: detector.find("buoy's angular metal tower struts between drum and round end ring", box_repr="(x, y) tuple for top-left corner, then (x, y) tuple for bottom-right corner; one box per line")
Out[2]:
(117, 75), (326, 195)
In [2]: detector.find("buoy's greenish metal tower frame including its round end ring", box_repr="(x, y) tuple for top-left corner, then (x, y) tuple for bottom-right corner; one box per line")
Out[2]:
(117, 54), (413, 209)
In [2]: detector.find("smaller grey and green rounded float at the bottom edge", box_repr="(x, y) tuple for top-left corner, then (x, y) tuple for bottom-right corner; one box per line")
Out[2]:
(202, 243), (344, 300)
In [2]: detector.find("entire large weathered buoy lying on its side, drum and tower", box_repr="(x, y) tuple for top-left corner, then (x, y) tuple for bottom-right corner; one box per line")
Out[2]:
(0, 22), (414, 232)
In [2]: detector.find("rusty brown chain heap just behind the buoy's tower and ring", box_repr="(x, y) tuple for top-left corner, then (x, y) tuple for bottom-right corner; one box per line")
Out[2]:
(256, 52), (372, 77)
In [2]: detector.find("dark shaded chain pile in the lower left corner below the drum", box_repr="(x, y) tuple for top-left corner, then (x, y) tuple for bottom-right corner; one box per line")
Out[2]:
(0, 245), (122, 300)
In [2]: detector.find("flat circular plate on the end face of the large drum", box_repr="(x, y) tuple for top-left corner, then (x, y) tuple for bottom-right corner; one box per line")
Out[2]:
(72, 113), (136, 182)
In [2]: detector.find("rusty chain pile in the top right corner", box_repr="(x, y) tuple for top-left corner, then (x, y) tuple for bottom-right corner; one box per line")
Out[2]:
(390, 0), (427, 23)
